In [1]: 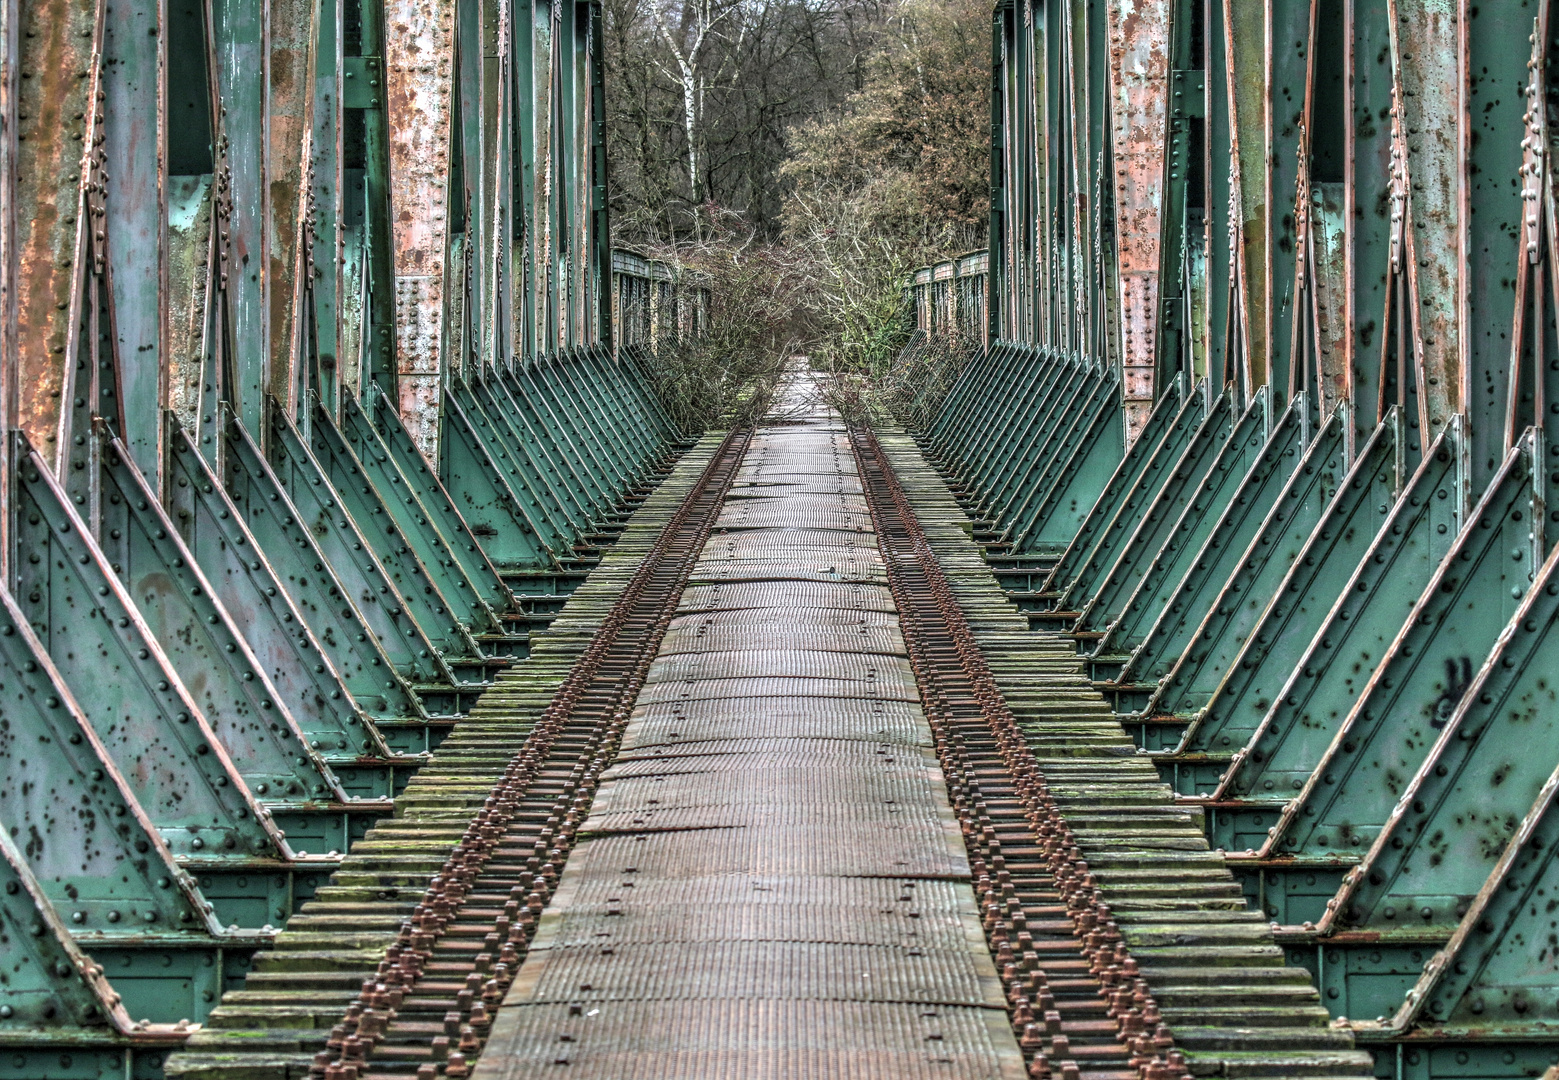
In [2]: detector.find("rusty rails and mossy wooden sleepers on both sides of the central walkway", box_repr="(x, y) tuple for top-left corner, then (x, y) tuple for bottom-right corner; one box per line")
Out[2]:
(167, 408), (1369, 1080)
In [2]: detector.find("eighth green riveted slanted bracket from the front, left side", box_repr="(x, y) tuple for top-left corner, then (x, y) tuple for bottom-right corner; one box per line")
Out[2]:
(299, 404), (497, 645)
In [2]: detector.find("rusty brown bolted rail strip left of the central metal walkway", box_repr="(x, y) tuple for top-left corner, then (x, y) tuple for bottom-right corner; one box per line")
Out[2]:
(310, 430), (751, 1080)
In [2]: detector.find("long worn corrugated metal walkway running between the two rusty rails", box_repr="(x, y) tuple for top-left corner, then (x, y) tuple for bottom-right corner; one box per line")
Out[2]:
(475, 372), (1024, 1080)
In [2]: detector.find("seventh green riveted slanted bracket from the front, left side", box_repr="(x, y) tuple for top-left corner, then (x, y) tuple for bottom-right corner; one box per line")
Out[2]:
(265, 402), (480, 683)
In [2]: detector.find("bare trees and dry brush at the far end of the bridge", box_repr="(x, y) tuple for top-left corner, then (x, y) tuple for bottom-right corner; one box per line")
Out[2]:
(606, 0), (990, 427)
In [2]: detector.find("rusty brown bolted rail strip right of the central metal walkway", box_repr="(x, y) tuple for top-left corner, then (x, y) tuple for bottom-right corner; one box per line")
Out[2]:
(851, 427), (1186, 1080)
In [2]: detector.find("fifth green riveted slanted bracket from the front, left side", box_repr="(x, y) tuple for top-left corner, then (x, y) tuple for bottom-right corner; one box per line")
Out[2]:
(164, 413), (390, 763)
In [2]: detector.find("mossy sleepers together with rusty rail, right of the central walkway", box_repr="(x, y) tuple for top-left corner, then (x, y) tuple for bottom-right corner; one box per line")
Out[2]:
(853, 429), (1372, 1080)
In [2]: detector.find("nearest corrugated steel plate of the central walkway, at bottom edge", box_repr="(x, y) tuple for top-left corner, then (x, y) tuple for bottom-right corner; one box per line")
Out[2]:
(477, 999), (1024, 1080)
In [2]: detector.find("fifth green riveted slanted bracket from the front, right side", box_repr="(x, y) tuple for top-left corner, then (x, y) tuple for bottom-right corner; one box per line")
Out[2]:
(1157, 414), (1409, 782)
